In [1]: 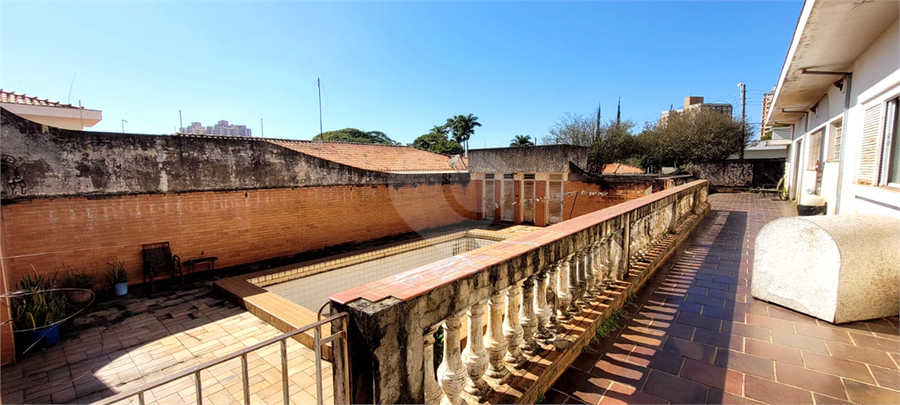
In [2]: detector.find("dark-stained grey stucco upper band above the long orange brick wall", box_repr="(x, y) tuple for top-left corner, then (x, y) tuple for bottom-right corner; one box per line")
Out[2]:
(0, 110), (468, 202)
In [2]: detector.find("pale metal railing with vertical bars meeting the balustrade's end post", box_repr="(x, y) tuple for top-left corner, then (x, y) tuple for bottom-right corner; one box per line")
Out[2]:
(94, 312), (350, 405)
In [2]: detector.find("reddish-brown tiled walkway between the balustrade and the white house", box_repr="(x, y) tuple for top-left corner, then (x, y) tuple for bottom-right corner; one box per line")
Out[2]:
(544, 194), (900, 404)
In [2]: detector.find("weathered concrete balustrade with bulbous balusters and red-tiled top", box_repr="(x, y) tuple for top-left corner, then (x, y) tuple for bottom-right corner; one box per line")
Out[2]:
(332, 181), (709, 405)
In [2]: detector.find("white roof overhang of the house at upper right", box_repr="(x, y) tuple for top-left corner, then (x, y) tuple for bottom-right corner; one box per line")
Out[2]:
(765, 0), (900, 125)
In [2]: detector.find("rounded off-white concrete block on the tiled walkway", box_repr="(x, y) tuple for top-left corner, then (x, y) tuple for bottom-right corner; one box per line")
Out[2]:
(750, 214), (900, 323)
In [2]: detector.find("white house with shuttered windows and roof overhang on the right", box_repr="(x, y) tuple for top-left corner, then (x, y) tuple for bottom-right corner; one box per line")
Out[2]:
(764, 0), (900, 217)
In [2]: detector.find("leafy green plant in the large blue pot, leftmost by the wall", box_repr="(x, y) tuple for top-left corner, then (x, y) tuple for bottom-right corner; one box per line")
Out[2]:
(11, 267), (66, 355)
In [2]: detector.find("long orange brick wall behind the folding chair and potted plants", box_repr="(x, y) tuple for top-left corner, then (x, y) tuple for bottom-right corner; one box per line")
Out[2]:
(0, 184), (476, 294)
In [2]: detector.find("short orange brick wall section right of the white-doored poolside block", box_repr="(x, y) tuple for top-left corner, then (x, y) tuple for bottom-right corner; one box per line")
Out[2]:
(563, 181), (652, 220)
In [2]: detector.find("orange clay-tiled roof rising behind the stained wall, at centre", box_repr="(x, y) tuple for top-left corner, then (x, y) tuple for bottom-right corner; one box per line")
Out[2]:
(267, 139), (467, 172)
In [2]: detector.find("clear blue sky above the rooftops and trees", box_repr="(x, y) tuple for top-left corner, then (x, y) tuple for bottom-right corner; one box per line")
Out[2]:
(0, 0), (802, 148)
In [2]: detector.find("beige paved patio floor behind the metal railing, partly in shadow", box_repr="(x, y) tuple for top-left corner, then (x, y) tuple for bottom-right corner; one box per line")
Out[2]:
(0, 283), (333, 405)
